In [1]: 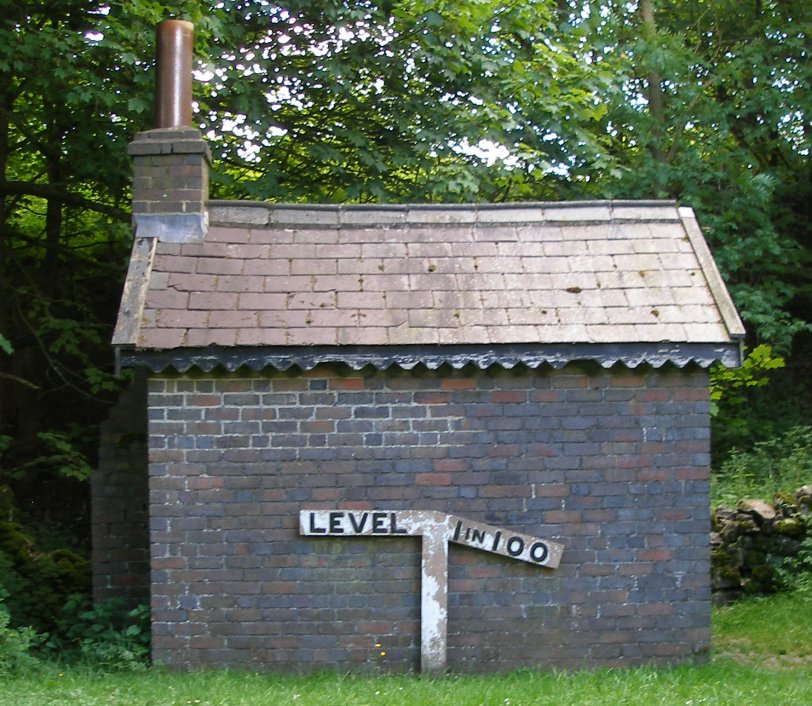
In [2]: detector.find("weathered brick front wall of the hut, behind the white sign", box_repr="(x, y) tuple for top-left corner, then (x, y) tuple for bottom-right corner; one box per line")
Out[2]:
(144, 364), (710, 672)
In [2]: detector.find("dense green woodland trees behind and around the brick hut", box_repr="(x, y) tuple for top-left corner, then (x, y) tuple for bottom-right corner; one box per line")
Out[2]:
(0, 0), (812, 656)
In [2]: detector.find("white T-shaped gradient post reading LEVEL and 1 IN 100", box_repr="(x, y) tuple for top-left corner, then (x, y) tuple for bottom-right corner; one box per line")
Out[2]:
(299, 510), (564, 672)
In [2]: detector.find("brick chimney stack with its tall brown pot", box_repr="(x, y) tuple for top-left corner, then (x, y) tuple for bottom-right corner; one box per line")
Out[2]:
(128, 20), (211, 243)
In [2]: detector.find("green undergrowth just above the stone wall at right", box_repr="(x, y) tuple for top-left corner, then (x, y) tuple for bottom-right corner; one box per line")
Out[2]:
(711, 426), (812, 506)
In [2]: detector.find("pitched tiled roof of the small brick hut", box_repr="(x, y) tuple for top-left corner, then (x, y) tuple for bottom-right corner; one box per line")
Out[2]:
(113, 202), (744, 364)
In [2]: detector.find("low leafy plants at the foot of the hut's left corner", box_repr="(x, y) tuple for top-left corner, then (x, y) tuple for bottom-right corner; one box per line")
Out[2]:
(48, 594), (150, 671)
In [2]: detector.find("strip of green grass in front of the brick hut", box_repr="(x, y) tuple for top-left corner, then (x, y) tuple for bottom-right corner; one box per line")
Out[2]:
(0, 593), (812, 706)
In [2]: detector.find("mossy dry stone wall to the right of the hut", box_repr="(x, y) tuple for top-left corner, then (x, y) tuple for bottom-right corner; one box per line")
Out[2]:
(711, 485), (812, 603)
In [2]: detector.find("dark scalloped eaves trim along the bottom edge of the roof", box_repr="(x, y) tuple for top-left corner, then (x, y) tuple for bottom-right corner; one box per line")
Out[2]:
(119, 343), (741, 373)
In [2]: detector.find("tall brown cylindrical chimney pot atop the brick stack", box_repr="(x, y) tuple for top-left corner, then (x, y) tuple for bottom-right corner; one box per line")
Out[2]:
(155, 20), (194, 128)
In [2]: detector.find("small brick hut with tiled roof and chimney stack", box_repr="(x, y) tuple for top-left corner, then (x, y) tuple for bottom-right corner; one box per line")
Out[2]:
(93, 20), (743, 672)
